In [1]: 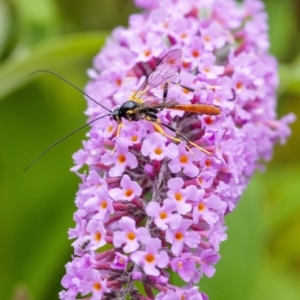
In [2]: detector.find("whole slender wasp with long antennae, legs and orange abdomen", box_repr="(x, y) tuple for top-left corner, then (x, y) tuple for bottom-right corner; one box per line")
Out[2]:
(24, 49), (221, 171)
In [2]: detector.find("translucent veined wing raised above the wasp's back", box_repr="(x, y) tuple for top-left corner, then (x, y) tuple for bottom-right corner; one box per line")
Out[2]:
(131, 49), (182, 105)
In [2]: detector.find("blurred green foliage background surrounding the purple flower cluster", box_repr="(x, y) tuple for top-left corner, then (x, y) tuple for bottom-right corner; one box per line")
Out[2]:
(0, 0), (300, 300)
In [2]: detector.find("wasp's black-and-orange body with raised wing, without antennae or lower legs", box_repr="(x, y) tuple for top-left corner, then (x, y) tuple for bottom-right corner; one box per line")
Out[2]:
(112, 49), (221, 123)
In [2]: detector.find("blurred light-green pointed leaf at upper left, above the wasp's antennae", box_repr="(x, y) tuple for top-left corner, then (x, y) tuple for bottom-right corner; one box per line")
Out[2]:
(0, 32), (107, 100)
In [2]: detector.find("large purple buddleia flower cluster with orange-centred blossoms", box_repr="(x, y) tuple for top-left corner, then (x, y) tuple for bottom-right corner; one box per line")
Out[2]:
(60, 0), (293, 300)
